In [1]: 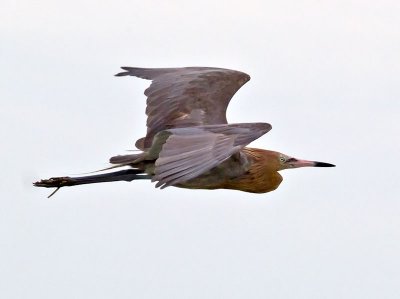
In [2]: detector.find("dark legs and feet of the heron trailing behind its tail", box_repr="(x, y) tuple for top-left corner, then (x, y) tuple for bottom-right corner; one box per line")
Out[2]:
(33, 169), (152, 197)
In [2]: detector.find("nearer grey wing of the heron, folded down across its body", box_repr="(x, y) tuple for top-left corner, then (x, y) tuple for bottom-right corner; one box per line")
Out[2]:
(149, 123), (271, 188)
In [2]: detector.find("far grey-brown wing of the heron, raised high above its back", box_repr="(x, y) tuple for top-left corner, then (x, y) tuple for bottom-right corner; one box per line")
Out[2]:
(116, 67), (250, 150)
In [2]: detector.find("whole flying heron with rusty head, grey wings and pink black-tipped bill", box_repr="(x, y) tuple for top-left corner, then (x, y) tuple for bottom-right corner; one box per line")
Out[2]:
(34, 67), (335, 197)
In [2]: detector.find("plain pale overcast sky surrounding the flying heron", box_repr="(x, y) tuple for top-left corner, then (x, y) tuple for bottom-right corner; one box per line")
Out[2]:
(0, 0), (400, 299)
